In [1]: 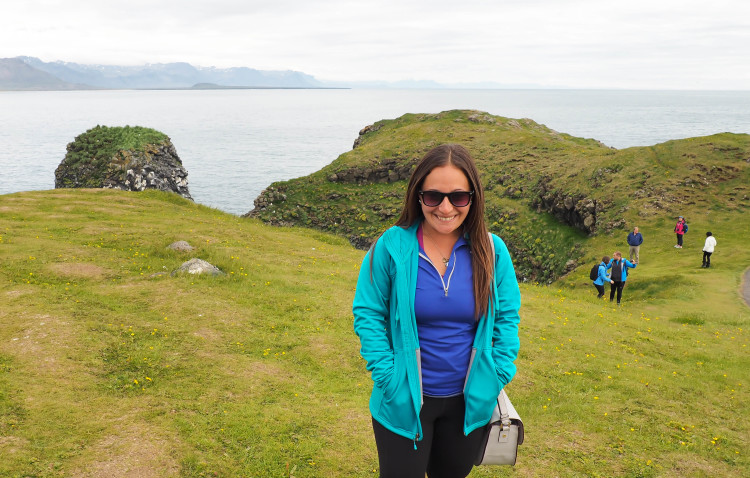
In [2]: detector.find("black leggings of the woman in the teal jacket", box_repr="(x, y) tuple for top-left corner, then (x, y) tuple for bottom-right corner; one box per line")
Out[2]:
(372, 395), (484, 478)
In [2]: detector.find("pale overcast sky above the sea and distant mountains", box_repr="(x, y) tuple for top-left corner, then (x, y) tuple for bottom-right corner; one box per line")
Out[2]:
(0, 0), (750, 90)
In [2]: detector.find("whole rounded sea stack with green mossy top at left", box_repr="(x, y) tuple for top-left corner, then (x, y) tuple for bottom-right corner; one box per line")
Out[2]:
(55, 126), (192, 199)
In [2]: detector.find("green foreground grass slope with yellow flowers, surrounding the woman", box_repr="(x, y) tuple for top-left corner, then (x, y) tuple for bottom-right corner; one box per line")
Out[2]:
(0, 189), (750, 477)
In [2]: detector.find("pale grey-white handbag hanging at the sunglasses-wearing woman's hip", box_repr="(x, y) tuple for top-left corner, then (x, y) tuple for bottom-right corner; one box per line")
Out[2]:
(475, 390), (523, 465)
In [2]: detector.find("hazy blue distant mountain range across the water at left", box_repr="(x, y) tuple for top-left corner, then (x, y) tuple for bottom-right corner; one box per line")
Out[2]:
(0, 56), (326, 90)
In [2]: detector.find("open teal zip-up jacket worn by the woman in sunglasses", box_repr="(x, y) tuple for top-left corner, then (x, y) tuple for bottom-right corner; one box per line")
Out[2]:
(352, 223), (521, 442)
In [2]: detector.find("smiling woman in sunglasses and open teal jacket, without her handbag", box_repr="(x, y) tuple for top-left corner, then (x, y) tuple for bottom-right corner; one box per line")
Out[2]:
(352, 144), (521, 478)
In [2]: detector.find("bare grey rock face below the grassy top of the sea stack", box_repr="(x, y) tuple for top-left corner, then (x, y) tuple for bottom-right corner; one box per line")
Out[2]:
(55, 139), (193, 200)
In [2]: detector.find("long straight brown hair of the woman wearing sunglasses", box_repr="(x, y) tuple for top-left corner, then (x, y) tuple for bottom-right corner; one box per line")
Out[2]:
(396, 144), (495, 319)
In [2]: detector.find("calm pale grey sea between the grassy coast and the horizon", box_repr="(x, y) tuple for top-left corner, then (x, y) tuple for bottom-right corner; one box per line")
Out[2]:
(0, 89), (750, 214)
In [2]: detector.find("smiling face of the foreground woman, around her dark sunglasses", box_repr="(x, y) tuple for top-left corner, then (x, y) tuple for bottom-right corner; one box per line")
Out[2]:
(422, 164), (471, 237)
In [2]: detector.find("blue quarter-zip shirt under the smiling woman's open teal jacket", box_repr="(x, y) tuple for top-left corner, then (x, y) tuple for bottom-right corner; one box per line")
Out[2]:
(414, 231), (477, 397)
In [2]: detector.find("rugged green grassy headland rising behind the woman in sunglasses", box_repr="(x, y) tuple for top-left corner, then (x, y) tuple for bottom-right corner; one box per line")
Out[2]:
(251, 110), (750, 282)
